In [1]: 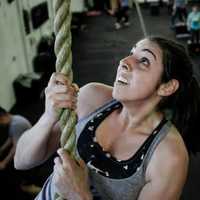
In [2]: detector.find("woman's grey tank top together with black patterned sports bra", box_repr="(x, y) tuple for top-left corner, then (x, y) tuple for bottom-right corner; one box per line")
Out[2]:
(36, 99), (171, 200)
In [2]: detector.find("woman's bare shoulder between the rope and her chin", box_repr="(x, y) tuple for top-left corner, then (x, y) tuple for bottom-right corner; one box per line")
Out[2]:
(77, 82), (112, 119)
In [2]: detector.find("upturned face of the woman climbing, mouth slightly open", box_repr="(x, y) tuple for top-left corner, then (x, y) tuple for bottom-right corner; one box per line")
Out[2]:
(113, 39), (163, 101)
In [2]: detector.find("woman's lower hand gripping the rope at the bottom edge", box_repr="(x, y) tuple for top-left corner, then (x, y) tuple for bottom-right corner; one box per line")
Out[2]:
(53, 149), (92, 200)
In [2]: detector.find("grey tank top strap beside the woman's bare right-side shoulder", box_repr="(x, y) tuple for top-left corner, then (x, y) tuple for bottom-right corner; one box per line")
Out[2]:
(142, 121), (172, 171)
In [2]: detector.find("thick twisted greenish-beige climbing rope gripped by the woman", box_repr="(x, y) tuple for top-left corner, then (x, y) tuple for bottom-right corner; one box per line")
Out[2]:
(53, 0), (77, 200)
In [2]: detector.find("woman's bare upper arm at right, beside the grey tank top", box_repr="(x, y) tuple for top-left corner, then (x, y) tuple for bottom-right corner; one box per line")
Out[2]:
(138, 127), (189, 200)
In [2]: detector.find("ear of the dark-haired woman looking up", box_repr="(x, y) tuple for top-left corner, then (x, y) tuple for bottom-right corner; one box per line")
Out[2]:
(157, 79), (179, 96)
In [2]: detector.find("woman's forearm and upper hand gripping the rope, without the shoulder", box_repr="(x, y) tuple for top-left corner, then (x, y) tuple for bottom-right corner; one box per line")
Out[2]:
(14, 73), (77, 169)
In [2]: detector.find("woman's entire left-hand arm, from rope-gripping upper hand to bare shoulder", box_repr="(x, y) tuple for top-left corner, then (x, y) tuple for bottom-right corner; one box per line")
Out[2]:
(14, 73), (112, 169)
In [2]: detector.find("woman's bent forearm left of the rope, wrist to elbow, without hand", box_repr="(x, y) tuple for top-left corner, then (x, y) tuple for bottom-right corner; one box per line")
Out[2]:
(14, 114), (59, 169)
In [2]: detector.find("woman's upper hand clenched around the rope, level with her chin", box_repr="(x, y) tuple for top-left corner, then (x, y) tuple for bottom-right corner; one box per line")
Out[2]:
(44, 72), (78, 122)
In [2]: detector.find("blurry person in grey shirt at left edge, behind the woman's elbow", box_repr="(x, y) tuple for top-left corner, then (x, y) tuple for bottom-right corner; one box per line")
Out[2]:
(0, 107), (31, 199)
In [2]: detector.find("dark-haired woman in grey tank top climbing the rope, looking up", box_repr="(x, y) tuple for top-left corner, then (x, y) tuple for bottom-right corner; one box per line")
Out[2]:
(15, 37), (200, 200)
